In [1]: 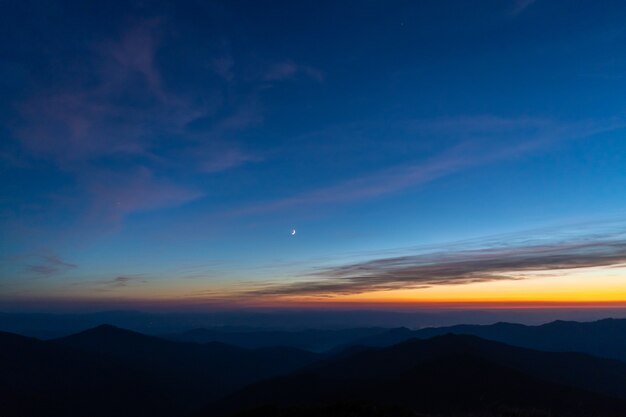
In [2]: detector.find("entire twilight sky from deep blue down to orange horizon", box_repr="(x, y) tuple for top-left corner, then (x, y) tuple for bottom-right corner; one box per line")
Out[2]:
(0, 0), (626, 310)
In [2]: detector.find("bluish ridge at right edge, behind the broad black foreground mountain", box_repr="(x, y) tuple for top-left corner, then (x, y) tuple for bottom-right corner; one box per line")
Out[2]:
(356, 319), (626, 361)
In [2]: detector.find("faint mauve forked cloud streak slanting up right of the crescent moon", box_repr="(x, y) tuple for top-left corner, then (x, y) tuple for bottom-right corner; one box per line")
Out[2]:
(231, 116), (624, 215)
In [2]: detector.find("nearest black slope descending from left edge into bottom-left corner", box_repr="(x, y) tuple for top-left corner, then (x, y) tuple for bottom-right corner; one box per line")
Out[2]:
(0, 332), (176, 417)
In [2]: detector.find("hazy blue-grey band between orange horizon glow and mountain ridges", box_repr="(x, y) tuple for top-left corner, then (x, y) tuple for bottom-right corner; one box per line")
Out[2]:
(0, 308), (626, 339)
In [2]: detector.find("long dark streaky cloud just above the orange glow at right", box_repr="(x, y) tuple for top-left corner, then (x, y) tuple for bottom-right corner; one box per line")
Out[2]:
(250, 224), (626, 297)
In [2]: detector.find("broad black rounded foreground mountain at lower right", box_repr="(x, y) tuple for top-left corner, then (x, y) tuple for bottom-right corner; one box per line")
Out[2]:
(206, 335), (626, 417)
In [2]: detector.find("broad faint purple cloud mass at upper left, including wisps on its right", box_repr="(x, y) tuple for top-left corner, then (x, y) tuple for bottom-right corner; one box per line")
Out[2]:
(15, 19), (263, 175)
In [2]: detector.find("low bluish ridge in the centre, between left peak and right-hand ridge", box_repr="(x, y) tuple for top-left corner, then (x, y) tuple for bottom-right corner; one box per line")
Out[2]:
(165, 327), (387, 352)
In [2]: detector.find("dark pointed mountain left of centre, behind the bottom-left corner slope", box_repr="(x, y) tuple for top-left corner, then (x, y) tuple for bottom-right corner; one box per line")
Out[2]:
(53, 325), (320, 406)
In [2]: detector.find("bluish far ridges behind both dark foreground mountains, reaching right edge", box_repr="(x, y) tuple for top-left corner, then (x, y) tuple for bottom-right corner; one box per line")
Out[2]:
(164, 319), (626, 360)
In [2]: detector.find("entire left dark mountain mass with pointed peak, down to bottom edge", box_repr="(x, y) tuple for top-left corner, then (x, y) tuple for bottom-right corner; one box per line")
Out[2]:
(0, 325), (319, 417)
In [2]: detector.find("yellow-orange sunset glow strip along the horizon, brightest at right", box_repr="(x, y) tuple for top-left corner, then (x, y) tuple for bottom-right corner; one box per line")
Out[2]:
(8, 265), (626, 309)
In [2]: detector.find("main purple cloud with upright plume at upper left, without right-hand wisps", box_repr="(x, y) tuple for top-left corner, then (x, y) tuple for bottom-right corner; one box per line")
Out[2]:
(17, 20), (168, 165)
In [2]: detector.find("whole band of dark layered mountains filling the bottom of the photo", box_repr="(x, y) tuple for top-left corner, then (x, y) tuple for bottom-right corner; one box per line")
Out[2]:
(0, 320), (626, 417)
